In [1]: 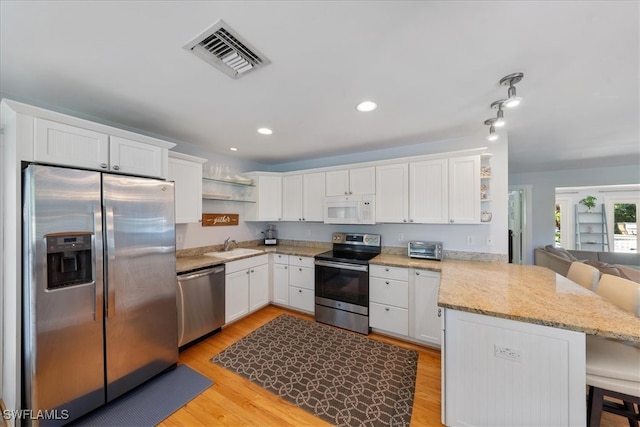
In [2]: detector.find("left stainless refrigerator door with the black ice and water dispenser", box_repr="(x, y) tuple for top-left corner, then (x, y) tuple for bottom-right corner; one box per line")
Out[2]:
(23, 165), (105, 422)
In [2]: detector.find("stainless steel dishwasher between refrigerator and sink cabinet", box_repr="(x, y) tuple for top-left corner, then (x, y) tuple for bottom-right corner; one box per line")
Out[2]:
(177, 265), (224, 347)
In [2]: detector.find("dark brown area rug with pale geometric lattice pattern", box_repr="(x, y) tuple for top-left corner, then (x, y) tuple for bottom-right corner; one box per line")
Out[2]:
(211, 314), (418, 426)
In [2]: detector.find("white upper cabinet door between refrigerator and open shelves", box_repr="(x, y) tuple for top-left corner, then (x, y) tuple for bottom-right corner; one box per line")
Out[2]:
(169, 157), (202, 224)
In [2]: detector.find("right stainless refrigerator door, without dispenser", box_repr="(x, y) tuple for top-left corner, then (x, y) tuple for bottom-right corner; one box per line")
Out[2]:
(103, 174), (178, 401)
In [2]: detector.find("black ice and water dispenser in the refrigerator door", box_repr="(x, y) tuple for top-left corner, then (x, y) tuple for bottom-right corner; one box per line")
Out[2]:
(45, 232), (93, 289)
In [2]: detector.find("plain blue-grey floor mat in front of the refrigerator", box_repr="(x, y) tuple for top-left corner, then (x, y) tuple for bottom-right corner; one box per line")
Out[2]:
(73, 365), (213, 427)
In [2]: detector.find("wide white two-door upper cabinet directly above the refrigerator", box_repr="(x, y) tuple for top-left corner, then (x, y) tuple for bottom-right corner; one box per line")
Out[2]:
(33, 117), (168, 178)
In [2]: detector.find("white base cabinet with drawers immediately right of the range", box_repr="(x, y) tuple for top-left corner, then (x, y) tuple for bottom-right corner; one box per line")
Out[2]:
(369, 265), (409, 336)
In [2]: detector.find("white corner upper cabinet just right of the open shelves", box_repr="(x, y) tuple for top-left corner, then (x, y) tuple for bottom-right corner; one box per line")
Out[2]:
(245, 173), (282, 221)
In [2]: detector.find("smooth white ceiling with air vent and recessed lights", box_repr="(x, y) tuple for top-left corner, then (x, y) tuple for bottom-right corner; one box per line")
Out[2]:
(0, 0), (640, 172)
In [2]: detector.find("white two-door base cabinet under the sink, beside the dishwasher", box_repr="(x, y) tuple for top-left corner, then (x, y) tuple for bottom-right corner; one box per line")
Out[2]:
(224, 255), (269, 323)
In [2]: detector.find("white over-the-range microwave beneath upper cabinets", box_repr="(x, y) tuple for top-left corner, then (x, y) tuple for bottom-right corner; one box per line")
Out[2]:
(324, 194), (376, 224)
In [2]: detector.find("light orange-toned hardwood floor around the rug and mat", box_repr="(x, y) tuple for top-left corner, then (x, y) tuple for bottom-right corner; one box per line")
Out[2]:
(159, 305), (627, 427)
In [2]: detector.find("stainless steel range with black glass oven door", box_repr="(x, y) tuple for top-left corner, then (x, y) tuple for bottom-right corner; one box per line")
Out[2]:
(315, 233), (381, 335)
